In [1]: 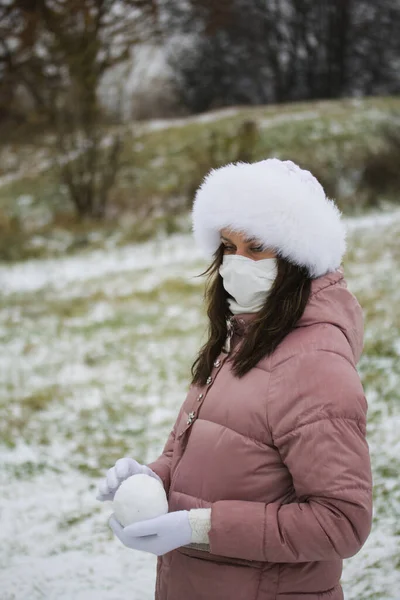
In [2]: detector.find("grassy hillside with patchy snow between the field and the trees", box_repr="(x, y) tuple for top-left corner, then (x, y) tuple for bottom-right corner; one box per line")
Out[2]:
(0, 98), (400, 261)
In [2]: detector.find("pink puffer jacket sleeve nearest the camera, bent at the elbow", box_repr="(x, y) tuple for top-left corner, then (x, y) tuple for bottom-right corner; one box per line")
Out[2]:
(209, 351), (372, 562)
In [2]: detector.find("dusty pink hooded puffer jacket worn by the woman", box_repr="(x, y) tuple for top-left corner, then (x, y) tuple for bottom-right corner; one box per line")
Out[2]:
(149, 269), (372, 600)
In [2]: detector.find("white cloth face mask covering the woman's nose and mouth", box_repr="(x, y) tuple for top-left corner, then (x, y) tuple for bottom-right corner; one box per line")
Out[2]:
(219, 254), (278, 314)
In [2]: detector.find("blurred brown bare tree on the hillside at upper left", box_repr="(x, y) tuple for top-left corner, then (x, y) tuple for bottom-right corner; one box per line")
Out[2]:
(1, 0), (157, 218)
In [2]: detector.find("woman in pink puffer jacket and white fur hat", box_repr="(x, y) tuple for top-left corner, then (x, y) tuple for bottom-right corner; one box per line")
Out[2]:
(98, 159), (372, 600)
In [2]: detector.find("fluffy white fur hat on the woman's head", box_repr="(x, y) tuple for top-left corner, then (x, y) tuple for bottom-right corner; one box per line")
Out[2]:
(192, 158), (346, 277)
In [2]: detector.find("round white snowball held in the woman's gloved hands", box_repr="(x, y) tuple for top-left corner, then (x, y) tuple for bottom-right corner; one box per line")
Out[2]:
(113, 474), (168, 527)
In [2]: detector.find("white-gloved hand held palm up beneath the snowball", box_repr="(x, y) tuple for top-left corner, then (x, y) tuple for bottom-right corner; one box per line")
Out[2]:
(109, 510), (192, 556)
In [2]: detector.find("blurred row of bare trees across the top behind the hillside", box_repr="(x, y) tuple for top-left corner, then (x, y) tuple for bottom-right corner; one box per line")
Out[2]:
(0, 0), (400, 124)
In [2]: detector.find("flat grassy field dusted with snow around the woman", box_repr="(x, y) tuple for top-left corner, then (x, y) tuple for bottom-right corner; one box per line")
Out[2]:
(0, 212), (400, 600)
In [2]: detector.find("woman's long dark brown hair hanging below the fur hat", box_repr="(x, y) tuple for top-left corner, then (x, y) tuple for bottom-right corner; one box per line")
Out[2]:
(191, 244), (312, 385)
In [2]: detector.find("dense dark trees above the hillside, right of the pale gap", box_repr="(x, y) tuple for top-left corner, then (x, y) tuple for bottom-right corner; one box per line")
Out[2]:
(167, 0), (400, 112)
